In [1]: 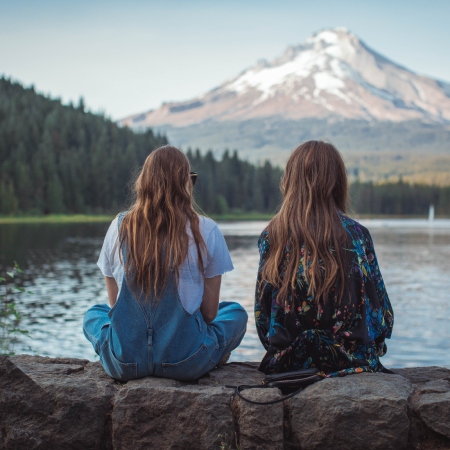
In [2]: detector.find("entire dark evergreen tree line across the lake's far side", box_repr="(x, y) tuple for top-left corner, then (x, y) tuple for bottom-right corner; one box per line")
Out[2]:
(0, 78), (450, 215)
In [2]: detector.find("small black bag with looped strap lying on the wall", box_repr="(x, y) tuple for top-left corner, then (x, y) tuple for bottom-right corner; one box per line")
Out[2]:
(225, 368), (326, 405)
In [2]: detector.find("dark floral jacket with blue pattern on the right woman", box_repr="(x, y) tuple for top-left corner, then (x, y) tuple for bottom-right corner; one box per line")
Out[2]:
(255, 214), (394, 377)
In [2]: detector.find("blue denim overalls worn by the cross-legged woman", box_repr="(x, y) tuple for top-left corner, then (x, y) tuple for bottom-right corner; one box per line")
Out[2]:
(83, 215), (247, 381)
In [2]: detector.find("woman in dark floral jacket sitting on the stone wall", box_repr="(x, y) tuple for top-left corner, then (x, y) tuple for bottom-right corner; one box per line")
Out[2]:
(255, 141), (394, 376)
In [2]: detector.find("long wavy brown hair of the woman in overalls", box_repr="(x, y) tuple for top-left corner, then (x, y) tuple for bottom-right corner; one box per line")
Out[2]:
(120, 145), (206, 299)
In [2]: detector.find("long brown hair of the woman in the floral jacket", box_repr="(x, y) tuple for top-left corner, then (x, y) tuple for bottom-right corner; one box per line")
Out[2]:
(262, 141), (348, 305)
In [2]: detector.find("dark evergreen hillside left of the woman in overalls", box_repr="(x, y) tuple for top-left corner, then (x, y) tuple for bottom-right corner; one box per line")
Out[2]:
(0, 78), (167, 214)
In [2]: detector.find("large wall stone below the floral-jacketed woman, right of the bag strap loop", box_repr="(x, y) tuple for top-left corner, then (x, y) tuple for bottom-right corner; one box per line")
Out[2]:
(287, 373), (413, 450)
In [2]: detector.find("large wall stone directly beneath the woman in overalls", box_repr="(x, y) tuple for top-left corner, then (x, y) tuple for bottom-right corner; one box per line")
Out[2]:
(112, 378), (235, 450)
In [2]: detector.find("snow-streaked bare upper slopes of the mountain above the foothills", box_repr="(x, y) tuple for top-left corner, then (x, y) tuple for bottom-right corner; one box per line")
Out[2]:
(120, 28), (450, 129)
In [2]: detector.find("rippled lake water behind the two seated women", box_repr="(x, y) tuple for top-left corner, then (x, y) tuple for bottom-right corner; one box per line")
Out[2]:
(0, 220), (450, 367)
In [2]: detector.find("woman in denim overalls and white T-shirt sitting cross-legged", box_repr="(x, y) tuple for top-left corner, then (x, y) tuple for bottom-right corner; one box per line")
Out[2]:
(83, 146), (247, 381)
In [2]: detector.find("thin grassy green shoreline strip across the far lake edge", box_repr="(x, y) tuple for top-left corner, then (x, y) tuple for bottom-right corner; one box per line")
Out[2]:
(0, 213), (450, 225)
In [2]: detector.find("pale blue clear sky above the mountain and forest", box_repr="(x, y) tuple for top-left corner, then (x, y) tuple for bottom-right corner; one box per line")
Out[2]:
(0, 0), (450, 120)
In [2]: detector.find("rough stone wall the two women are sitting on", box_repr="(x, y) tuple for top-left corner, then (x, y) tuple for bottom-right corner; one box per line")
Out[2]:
(0, 355), (450, 450)
